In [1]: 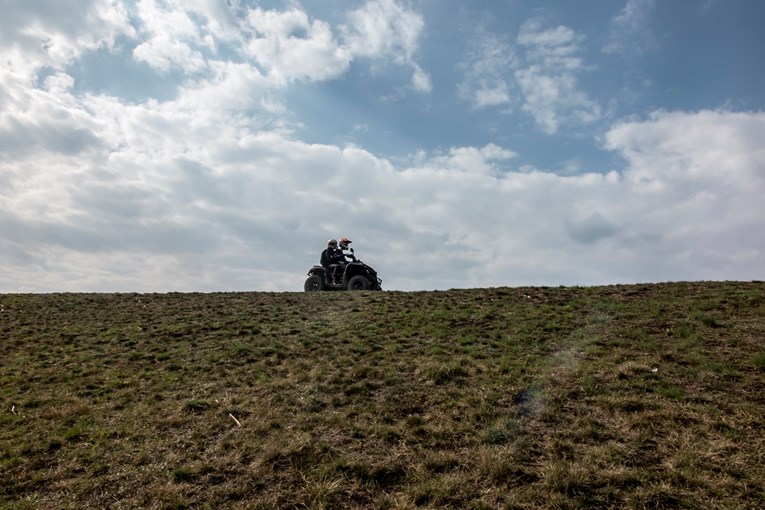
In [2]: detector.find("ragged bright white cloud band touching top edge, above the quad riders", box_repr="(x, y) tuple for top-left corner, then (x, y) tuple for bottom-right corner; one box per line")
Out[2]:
(133, 0), (432, 92)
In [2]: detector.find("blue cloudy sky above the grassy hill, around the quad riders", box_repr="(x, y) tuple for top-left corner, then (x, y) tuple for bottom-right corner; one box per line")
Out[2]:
(0, 0), (765, 293)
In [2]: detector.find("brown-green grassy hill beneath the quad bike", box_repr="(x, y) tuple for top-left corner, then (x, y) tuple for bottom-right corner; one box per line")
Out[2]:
(0, 283), (765, 509)
